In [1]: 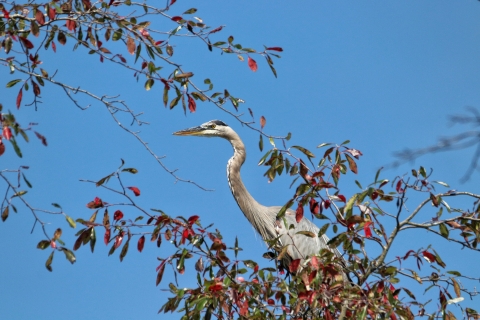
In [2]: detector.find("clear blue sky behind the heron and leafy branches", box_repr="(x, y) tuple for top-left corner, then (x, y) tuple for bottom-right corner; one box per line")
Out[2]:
(0, 0), (480, 319)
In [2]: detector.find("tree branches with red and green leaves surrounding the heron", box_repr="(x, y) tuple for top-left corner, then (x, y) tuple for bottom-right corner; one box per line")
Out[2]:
(2, 1), (478, 318)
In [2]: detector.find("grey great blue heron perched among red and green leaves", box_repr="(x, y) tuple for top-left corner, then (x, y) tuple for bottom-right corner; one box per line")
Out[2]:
(173, 120), (340, 268)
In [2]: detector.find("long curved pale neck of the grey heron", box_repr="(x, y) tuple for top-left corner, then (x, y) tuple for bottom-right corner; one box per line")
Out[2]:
(227, 134), (262, 220)
